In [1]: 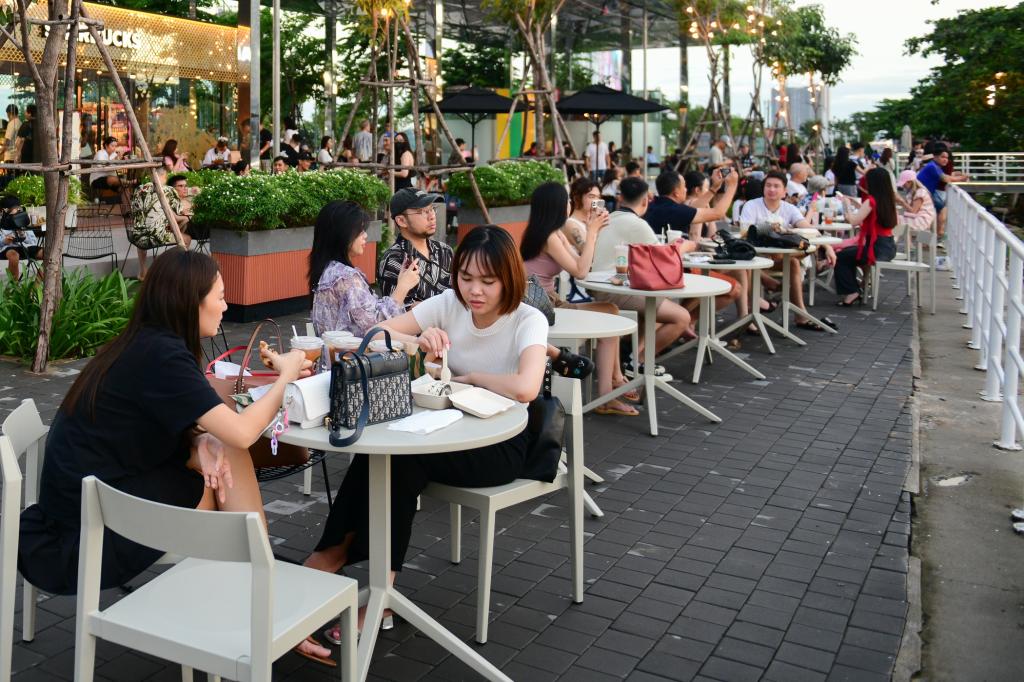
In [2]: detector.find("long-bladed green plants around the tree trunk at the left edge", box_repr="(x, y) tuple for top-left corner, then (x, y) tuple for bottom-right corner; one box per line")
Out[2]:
(0, 268), (138, 360)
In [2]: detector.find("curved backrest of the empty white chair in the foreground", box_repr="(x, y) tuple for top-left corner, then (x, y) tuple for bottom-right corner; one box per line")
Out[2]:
(82, 476), (273, 565)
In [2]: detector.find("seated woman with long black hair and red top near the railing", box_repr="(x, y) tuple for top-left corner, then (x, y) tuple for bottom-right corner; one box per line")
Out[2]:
(836, 167), (897, 307)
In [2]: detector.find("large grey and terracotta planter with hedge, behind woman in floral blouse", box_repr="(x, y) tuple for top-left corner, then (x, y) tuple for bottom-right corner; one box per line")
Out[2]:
(193, 169), (388, 322)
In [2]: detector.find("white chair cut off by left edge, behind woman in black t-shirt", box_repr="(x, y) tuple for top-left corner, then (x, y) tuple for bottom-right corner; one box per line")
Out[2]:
(0, 399), (48, 682)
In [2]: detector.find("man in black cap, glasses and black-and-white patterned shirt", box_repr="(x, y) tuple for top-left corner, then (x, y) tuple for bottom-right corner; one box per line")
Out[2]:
(377, 187), (454, 306)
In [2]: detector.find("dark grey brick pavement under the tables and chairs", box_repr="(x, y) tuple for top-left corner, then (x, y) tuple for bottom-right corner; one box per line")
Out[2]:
(0, 282), (911, 682)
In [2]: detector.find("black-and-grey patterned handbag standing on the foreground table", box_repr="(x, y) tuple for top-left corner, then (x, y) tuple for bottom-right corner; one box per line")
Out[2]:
(327, 327), (413, 447)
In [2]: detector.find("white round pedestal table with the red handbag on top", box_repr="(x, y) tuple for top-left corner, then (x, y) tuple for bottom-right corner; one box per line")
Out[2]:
(583, 273), (730, 435)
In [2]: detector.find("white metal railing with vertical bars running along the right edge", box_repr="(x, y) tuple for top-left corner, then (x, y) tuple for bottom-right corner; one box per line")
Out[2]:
(946, 185), (1024, 450)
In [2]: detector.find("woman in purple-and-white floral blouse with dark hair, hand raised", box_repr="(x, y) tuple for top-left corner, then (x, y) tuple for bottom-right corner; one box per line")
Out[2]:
(309, 202), (420, 336)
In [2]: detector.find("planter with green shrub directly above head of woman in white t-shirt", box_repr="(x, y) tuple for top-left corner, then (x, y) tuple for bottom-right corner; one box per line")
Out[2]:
(447, 161), (565, 244)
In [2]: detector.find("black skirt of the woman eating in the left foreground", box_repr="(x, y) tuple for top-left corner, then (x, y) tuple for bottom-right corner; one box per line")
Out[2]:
(17, 463), (204, 594)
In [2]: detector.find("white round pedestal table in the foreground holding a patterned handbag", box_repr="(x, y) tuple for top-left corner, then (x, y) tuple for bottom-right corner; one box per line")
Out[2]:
(279, 404), (528, 682)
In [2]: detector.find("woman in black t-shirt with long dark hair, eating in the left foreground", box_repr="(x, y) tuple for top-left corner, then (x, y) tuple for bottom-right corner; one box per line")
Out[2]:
(17, 249), (309, 594)
